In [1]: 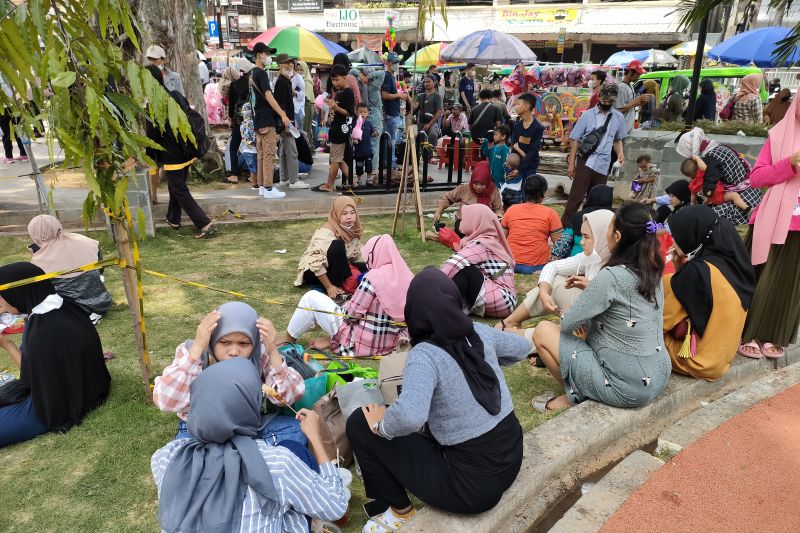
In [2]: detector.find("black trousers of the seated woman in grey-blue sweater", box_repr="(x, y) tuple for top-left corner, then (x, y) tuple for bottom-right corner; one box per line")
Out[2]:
(347, 409), (522, 514)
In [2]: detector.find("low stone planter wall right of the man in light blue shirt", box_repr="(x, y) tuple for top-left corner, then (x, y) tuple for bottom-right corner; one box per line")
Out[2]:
(609, 130), (765, 199)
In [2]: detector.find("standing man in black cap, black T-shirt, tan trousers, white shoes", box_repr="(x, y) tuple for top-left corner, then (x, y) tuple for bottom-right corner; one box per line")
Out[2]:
(250, 43), (294, 199)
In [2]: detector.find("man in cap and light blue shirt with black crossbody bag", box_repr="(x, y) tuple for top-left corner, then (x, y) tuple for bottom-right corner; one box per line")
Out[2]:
(561, 84), (628, 224)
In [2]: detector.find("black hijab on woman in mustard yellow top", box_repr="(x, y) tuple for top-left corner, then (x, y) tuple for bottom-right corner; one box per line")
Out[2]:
(669, 205), (756, 337)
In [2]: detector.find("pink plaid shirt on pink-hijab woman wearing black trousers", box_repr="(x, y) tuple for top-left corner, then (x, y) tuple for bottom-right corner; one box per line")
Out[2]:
(441, 241), (517, 318)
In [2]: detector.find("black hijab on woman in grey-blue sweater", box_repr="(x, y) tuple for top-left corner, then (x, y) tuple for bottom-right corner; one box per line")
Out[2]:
(405, 267), (500, 415)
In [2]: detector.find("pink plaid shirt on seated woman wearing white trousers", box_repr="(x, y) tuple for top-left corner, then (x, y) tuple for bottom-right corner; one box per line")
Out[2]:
(331, 274), (408, 357)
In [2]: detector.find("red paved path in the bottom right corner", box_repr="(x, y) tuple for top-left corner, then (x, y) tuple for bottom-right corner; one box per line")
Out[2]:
(601, 385), (800, 533)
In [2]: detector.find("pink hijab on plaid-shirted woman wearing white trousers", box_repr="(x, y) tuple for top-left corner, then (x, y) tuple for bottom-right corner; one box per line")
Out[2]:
(361, 235), (414, 322)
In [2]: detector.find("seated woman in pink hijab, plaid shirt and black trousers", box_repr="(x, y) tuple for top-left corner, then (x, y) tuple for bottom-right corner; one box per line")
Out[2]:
(442, 204), (517, 318)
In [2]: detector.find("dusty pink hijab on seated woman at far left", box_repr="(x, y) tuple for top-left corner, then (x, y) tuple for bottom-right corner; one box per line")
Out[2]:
(28, 215), (100, 278)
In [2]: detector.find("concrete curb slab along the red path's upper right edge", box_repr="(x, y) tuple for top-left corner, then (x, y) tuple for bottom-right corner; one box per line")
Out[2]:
(656, 354), (800, 457)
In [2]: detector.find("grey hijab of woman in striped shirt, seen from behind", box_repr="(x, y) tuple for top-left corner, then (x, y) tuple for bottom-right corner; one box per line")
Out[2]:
(158, 358), (277, 533)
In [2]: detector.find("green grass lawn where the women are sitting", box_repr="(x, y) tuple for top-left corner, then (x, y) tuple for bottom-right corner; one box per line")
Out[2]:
(0, 210), (557, 533)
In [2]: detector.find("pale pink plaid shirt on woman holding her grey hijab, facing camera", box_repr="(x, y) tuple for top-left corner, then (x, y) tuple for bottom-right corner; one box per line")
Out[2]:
(153, 343), (306, 420)
